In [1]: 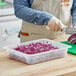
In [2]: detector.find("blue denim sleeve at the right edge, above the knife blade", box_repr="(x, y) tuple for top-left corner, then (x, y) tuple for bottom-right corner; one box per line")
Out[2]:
(71, 0), (76, 26)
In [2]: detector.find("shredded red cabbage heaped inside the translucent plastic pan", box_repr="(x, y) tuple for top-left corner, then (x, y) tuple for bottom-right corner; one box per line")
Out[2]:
(14, 42), (58, 54)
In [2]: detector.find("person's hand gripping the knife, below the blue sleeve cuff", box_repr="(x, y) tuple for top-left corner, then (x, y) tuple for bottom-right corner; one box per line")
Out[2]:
(47, 17), (65, 32)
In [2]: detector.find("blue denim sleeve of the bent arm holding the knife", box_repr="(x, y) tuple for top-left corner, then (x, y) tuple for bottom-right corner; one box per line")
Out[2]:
(14, 0), (53, 25)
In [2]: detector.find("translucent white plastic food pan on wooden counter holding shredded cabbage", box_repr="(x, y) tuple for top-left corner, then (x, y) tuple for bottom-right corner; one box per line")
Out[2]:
(7, 39), (71, 64)
